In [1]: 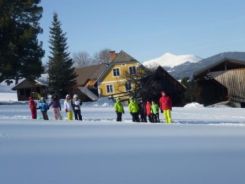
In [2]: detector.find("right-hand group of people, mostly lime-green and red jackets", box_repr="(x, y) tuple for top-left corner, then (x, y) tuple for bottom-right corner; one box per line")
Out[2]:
(114, 91), (172, 124)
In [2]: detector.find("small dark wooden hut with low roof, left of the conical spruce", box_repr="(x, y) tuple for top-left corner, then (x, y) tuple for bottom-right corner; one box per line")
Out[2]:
(13, 79), (48, 101)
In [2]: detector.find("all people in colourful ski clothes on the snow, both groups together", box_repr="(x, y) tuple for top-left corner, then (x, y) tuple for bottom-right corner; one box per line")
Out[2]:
(29, 91), (172, 124)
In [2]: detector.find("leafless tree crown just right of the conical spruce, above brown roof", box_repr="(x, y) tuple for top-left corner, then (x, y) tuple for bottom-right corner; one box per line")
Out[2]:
(73, 51), (93, 67)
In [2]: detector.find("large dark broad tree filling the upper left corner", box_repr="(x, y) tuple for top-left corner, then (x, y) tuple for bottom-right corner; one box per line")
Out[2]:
(0, 0), (44, 82)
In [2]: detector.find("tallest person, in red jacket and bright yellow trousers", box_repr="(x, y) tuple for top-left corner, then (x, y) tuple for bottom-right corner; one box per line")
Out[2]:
(159, 91), (172, 124)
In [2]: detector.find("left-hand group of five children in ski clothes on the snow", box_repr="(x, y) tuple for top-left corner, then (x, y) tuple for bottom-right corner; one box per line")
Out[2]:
(29, 94), (82, 120)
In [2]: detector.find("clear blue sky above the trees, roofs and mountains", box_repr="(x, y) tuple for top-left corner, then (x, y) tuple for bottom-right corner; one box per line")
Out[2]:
(40, 0), (245, 62)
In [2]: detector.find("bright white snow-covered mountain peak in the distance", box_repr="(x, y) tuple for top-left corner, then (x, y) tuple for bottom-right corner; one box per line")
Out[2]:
(143, 53), (202, 68)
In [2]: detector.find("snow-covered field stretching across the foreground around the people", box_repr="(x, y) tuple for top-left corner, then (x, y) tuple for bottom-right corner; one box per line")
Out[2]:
(0, 104), (245, 184)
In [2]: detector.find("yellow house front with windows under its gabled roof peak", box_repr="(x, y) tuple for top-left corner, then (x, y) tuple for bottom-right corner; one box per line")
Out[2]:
(98, 51), (145, 97)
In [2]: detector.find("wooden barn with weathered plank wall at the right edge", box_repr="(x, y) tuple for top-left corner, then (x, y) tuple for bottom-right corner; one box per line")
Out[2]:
(194, 58), (245, 106)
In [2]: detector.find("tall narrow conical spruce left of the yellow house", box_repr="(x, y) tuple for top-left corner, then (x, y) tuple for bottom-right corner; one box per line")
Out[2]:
(48, 13), (76, 97)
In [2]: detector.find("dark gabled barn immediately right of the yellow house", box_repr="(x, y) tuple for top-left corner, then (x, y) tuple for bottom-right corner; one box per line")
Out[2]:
(140, 67), (185, 106)
